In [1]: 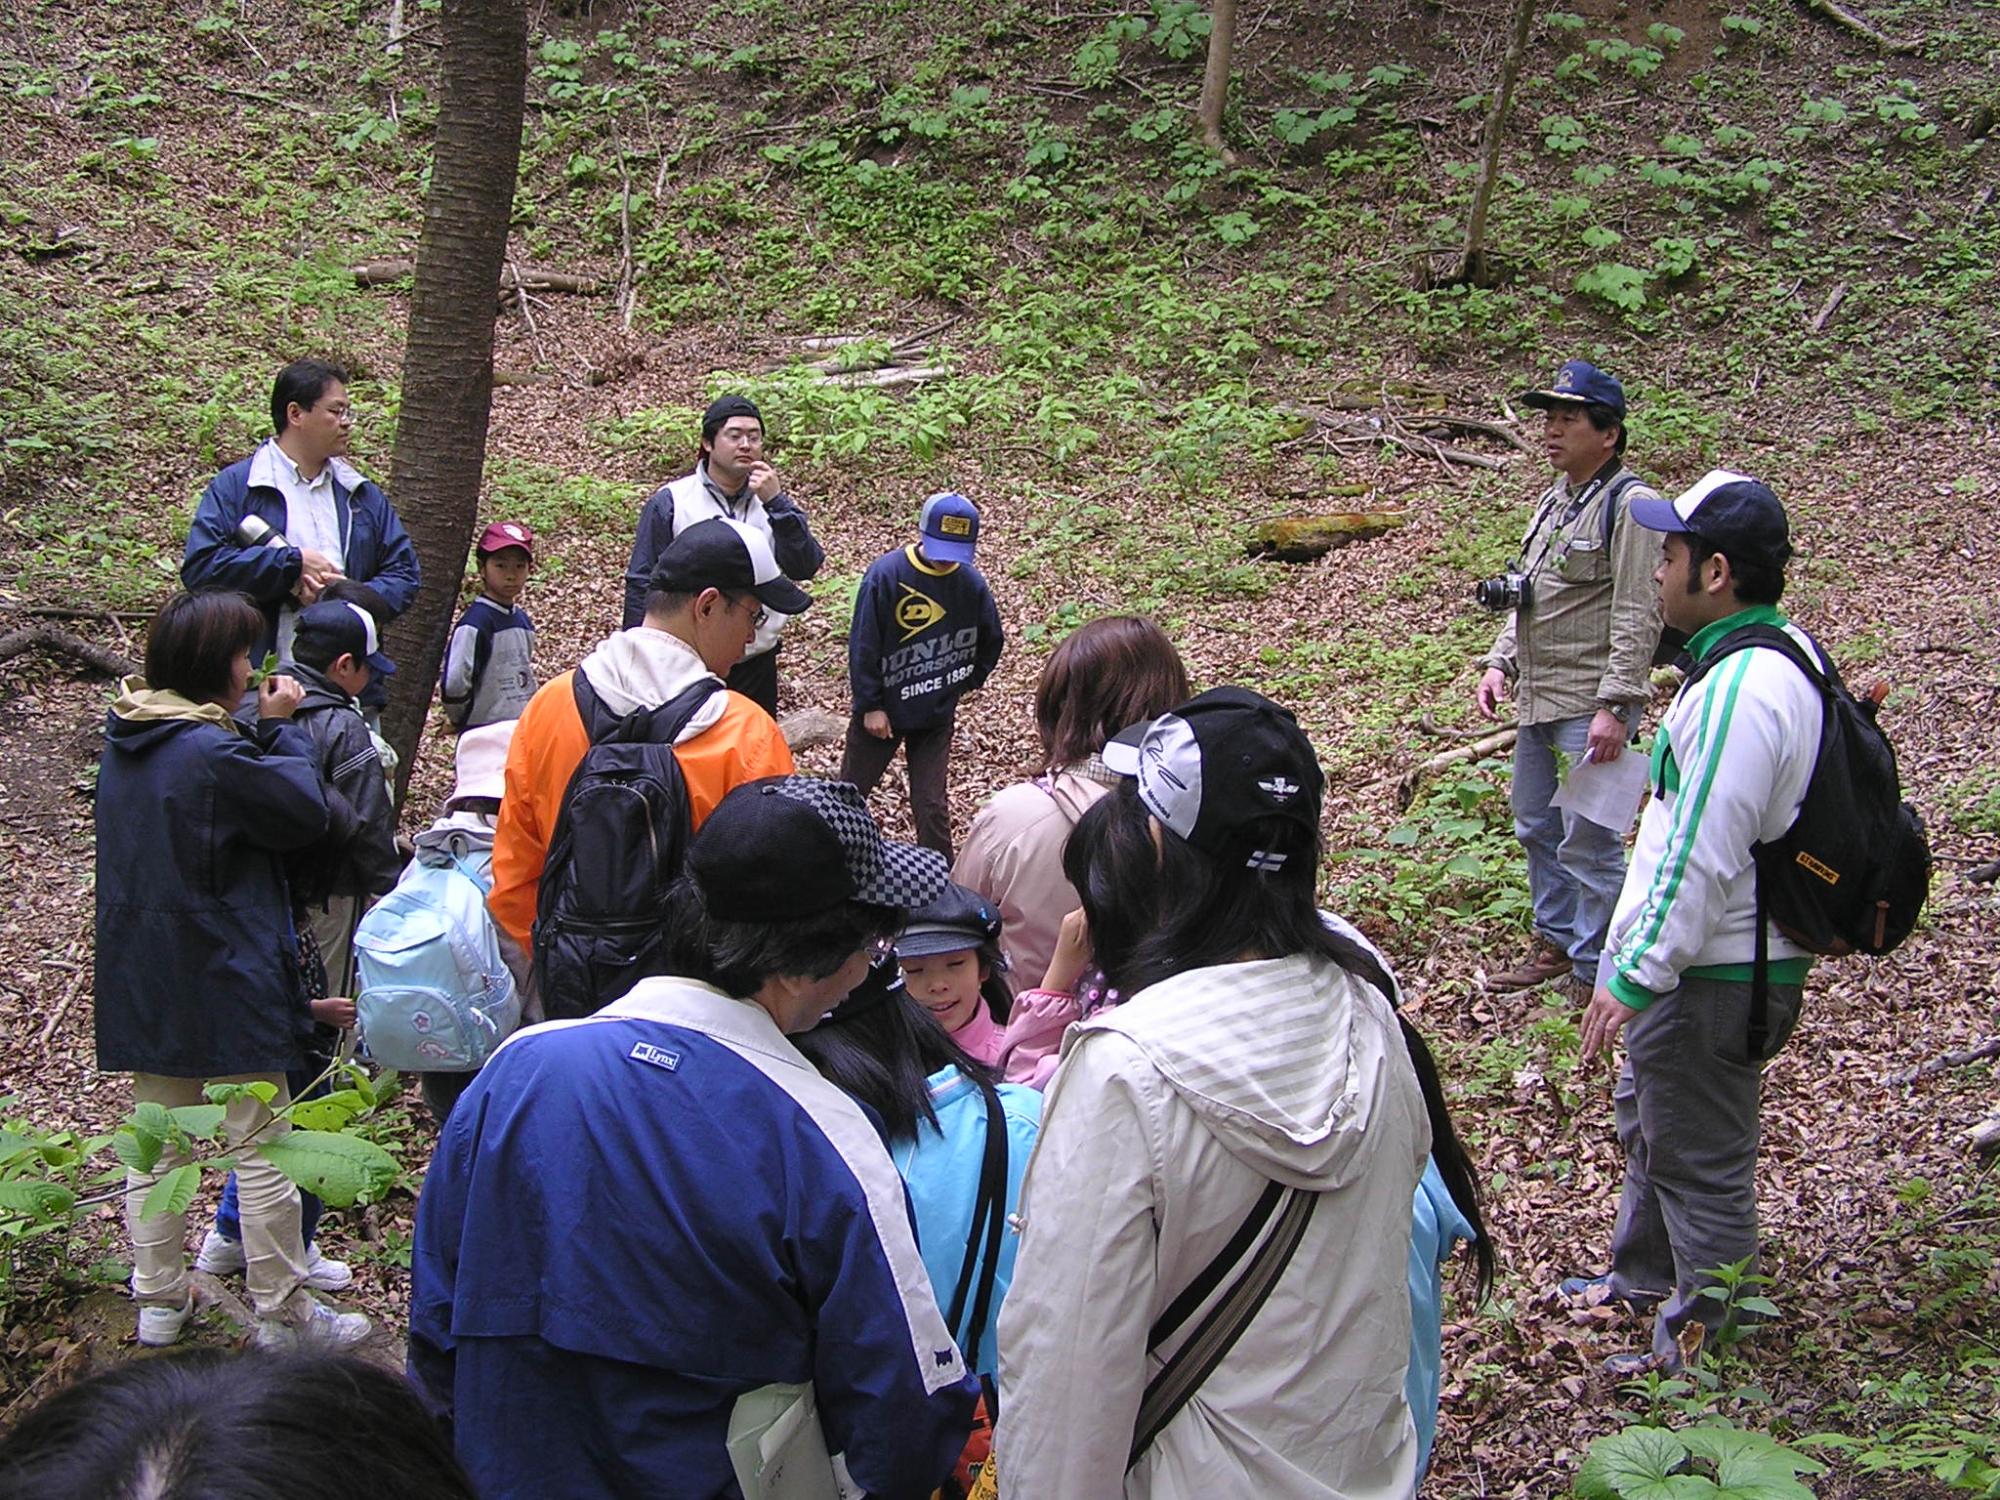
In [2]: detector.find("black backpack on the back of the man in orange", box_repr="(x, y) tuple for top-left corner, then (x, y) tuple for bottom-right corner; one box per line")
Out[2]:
(534, 672), (722, 1020)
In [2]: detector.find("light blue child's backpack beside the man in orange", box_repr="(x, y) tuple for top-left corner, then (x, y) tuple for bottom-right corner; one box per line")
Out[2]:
(354, 826), (520, 1072)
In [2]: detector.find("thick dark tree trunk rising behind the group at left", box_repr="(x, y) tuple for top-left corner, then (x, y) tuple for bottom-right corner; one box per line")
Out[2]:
(382, 0), (528, 800)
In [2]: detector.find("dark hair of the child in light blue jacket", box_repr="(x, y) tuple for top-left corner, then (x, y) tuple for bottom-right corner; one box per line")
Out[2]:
(792, 958), (994, 1142)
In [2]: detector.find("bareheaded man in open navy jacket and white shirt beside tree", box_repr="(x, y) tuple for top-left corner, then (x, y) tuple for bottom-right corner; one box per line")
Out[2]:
(180, 360), (422, 718)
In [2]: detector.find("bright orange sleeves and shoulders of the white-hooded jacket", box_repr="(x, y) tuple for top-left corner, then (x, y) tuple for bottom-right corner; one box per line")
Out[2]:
(486, 672), (792, 952)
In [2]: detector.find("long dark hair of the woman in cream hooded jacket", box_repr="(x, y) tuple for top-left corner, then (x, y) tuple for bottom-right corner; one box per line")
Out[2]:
(1062, 782), (1494, 1298)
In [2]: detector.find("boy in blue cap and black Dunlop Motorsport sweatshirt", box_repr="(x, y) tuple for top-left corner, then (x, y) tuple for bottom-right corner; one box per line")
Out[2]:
(840, 492), (1004, 858)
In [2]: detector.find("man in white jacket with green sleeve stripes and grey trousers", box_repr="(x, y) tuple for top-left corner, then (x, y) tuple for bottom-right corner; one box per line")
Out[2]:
(1564, 470), (1824, 1372)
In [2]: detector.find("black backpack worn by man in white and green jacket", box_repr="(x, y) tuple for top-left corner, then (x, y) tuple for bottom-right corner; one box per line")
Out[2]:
(1688, 624), (1930, 1052)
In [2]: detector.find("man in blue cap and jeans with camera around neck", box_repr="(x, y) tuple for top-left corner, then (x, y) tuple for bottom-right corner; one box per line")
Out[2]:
(1476, 360), (1660, 1000)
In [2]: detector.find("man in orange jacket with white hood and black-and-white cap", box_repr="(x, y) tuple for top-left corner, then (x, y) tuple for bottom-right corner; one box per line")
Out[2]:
(486, 518), (812, 954)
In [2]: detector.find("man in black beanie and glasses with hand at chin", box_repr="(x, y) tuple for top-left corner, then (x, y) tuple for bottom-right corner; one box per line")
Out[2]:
(622, 396), (826, 718)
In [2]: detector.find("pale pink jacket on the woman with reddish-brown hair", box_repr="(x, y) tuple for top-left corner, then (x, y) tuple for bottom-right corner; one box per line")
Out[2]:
(952, 756), (1116, 1000)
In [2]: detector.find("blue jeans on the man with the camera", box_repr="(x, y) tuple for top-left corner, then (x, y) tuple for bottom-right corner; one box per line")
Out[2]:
(1512, 718), (1634, 984)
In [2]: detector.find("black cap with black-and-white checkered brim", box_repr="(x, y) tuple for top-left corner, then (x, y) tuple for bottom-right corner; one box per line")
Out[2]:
(688, 776), (948, 922)
